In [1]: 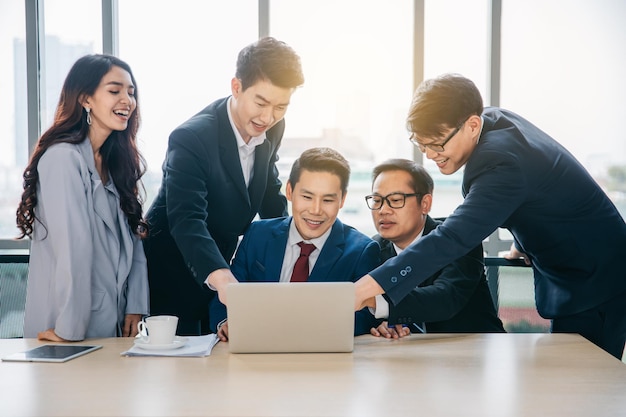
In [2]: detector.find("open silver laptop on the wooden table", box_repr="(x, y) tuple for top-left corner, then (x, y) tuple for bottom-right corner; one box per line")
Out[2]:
(227, 282), (355, 353)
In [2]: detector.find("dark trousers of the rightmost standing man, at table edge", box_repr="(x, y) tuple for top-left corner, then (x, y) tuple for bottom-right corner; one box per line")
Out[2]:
(550, 292), (626, 360)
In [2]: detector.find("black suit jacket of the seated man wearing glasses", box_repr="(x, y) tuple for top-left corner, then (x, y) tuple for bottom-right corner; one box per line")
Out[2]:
(374, 216), (504, 333)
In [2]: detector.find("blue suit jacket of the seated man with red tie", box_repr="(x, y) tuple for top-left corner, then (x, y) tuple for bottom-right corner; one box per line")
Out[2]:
(210, 217), (380, 335)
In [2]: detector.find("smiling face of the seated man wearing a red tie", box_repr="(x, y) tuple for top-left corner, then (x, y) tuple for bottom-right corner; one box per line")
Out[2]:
(286, 169), (346, 240)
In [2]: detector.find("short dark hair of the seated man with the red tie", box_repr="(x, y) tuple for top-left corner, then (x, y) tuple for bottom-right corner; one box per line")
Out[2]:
(289, 148), (350, 195)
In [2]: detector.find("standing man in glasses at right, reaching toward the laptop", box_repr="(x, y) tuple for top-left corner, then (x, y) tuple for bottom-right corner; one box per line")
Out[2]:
(355, 74), (626, 358)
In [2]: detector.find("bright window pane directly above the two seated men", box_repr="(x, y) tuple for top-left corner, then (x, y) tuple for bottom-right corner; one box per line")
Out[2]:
(270, 0), (413, 234)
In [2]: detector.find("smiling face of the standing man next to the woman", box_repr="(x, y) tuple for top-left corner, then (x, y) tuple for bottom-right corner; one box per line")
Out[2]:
(231, 78), (294, 143)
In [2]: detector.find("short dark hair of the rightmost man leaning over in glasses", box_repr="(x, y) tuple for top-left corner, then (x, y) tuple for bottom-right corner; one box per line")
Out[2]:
(407, 74), (483, 138)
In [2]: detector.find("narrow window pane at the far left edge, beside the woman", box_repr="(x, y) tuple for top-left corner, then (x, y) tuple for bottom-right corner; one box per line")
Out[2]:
(0, 1), (28, 239)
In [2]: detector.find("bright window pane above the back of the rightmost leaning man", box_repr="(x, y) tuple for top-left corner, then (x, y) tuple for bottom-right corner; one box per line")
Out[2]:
(501, 0), (626, 215)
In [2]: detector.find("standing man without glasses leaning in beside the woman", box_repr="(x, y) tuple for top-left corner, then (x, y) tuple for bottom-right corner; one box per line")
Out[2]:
(144, 37), (304, 335)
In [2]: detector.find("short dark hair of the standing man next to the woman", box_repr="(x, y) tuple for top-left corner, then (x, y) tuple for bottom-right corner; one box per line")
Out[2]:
(235, 36), (304, 90)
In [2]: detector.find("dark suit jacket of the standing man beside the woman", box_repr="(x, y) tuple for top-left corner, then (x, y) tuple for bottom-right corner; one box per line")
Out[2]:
(144, 98), (287, 319)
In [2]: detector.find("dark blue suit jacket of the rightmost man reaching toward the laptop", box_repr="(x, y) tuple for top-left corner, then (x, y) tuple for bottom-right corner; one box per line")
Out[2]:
(371, 108), (626, 318)
